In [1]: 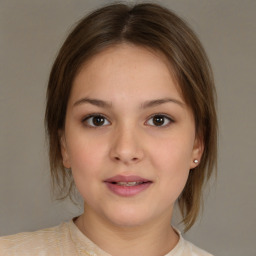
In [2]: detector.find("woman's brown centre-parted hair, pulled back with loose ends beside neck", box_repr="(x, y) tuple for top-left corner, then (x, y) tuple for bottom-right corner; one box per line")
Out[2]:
(45, 3), (217, 230)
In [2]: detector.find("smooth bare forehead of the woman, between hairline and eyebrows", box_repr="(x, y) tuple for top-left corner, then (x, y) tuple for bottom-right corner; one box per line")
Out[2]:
(71, 43), (182, 101)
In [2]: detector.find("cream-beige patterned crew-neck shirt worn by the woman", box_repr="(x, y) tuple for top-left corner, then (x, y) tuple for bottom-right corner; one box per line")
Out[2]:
(0, 220), (212, 256)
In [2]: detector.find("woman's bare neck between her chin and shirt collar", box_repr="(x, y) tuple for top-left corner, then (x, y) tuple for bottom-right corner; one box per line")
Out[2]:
(75, 208), (179, 256)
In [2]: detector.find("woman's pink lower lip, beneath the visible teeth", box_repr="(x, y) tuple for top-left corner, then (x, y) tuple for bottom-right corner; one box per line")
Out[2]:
(106, 182), (152, 197)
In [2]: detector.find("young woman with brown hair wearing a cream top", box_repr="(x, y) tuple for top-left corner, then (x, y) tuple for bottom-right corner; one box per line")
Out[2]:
(0, 4), (217, 256)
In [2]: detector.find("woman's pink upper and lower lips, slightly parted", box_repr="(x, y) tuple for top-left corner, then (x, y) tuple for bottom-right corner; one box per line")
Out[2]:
(104, 175), (153, 197)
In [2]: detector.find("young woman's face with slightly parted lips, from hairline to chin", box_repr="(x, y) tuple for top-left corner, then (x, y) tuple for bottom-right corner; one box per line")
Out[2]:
(61, 44), (202, 226)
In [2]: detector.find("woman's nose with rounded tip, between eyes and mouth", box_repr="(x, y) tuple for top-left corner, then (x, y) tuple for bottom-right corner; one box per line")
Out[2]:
(110, 127), (144, 165)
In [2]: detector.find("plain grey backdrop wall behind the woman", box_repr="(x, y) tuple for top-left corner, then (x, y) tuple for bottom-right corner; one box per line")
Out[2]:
(0, 0), (256, 256)
